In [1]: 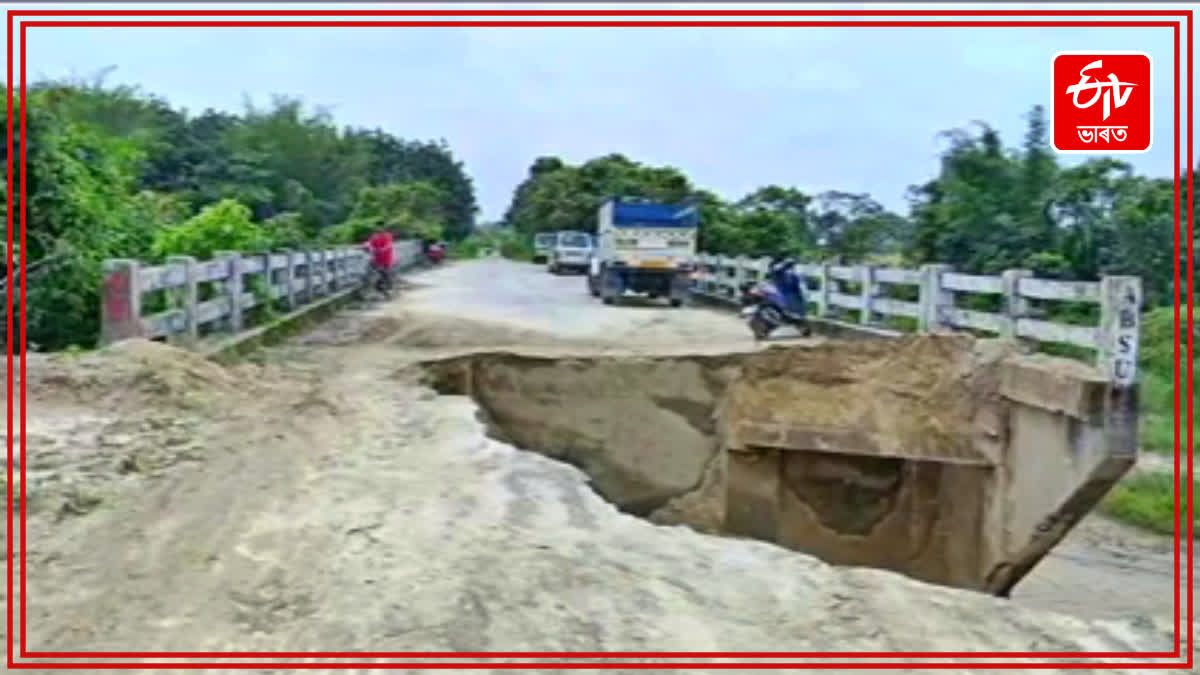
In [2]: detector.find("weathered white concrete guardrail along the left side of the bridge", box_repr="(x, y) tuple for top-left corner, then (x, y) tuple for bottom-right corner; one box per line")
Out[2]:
(100, 241), (421, 345)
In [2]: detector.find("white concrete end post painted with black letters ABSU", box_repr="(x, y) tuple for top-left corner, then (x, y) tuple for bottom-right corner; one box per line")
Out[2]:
(1096, 276), (1141, 389)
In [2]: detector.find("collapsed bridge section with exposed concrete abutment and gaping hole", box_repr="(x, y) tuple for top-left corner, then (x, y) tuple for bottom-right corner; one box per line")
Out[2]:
(422, 335), (1136, 595)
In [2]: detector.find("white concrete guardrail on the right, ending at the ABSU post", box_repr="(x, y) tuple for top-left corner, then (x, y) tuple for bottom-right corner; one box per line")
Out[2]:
(695, 255), (1142, 387)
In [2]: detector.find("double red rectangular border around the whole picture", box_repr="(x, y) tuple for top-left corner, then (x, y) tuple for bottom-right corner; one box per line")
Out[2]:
(6, 10), (1194, 669)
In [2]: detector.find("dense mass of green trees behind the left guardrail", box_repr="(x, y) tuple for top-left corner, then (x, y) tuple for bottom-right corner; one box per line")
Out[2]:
(6, 77), (478, 350)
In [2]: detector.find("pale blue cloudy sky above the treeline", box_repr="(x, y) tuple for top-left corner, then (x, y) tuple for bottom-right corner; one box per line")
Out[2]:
(7, 4), (1200, 221)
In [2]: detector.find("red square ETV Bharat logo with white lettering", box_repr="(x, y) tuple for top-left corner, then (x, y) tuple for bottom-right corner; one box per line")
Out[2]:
(1050, 52), (1153, 154)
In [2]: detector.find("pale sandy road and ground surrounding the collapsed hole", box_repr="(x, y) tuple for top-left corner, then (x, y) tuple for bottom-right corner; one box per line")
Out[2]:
(4, 255), (1195, 671)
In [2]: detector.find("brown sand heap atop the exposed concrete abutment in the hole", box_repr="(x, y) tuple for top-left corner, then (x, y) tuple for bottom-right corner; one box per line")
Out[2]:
(725, 335), (1020, 466)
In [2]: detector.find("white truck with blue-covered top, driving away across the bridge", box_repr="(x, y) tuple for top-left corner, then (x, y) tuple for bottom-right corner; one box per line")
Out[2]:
(588, 197), (700, 307)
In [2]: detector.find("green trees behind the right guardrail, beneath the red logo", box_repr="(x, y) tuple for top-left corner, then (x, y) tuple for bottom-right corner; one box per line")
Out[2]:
(905, 108), (1187, 306)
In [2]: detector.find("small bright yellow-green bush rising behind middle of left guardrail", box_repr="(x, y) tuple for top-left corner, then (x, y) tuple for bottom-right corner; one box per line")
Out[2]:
(151, 199), (271, 259)
